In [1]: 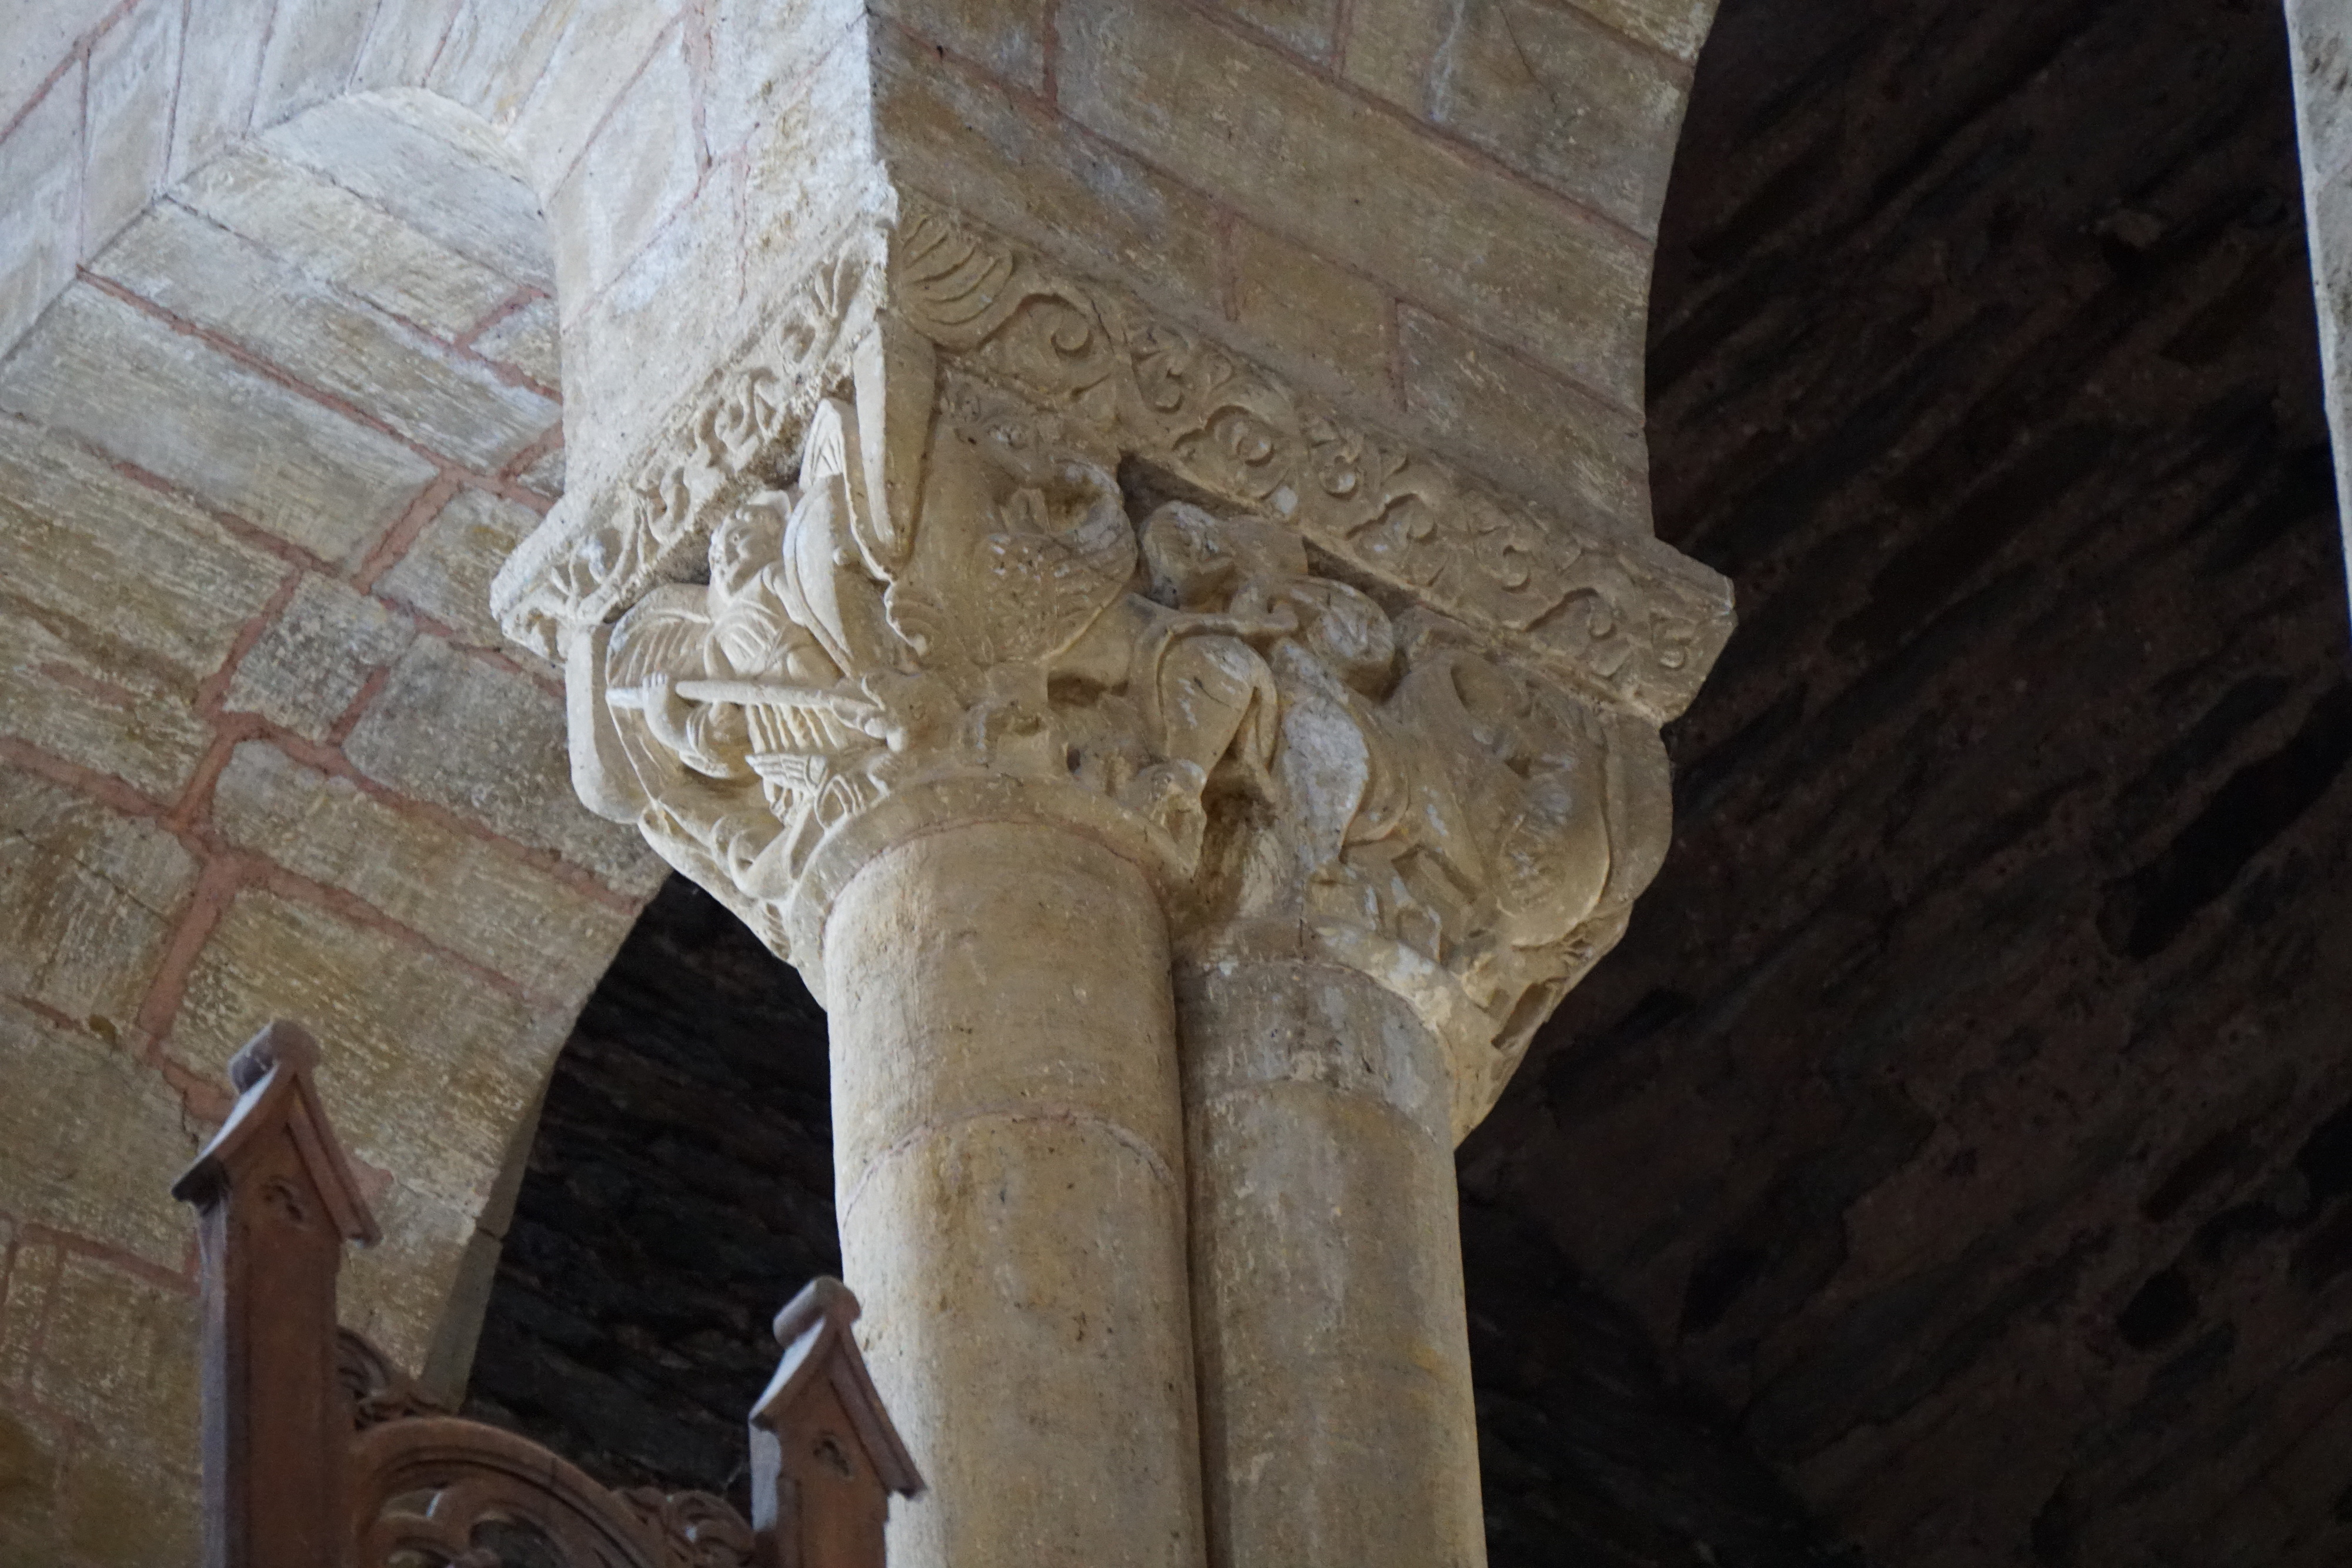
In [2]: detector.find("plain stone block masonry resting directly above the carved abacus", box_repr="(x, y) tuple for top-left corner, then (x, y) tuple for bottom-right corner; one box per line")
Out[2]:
(550, 0), (1715, 531)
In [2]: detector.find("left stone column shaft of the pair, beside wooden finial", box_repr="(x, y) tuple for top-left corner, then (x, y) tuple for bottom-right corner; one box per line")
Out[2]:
(826, 823), (1202, 1568)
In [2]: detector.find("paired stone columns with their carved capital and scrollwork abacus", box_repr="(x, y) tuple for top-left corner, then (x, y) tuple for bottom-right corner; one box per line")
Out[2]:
(496, 205), (1729, 1568)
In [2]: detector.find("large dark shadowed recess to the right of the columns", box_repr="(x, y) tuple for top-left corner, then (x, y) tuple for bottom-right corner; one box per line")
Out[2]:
(1465, 0), (2352, 1568)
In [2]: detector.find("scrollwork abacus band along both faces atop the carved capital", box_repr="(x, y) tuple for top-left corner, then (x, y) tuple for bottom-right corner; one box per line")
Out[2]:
(496, 198), (1731, 722)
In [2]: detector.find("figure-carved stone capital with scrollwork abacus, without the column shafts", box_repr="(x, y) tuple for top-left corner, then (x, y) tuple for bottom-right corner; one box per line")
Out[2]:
(501, 212), (1729, 1133)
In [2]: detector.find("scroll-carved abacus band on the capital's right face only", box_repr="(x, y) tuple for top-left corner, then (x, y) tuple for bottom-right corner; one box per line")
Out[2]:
(889, 202), (1731, 724)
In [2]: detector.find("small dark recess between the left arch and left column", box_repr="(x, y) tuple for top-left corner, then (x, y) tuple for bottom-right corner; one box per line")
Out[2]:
(466, 877), (842, 1500)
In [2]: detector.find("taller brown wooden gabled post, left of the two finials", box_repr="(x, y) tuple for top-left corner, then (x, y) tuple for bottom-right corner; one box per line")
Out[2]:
(172, 1022), (376, 1568)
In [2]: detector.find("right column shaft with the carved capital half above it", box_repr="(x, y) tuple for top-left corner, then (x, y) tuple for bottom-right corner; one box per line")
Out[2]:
(1145, 508), (1668, 1568)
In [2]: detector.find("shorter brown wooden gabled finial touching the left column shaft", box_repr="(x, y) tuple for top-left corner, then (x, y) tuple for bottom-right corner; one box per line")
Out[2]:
(750, 1279), (922, 1568)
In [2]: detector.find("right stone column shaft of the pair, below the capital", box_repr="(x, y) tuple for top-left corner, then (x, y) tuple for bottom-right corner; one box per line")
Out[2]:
(1178, 959), (1486, 1568)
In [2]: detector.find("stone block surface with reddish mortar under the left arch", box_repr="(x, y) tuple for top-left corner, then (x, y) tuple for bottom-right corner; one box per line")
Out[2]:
(0, 79), (661, 1568)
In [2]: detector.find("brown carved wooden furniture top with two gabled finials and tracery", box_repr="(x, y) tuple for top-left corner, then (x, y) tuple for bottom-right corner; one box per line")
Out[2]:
(172, 1022), (922, 1568)
